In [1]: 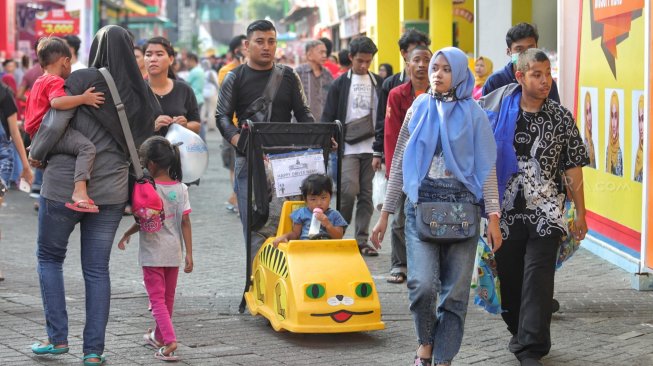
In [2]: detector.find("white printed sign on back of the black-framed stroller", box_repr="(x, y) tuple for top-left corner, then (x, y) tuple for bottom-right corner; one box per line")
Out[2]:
(268, 149), (325, 197)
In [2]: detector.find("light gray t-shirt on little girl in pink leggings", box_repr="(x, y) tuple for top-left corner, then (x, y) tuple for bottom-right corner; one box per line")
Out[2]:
(138, 181), (191, 267)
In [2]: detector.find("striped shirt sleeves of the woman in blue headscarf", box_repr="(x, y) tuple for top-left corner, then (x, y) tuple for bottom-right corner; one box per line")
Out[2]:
(383, 107), (501, 214)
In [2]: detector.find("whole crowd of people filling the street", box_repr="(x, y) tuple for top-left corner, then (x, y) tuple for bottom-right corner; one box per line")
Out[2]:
(0, 20), (590, 366)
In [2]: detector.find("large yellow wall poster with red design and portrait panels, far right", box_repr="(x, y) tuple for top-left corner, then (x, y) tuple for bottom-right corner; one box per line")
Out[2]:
(562, 0), (648, 254)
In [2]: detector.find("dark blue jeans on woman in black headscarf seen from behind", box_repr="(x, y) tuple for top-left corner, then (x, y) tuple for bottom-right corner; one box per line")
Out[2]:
(36, 196), (125, 354)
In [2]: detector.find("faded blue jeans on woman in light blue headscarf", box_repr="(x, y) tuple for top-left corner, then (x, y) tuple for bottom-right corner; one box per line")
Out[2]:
(405, 199), (480, 365)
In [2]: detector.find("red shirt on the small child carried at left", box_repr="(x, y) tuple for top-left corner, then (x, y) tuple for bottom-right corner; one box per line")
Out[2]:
(25, 74), (66, 137)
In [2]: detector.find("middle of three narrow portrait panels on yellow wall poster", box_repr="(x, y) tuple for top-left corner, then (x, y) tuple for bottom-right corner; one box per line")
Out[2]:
(603, 89), (626, 177)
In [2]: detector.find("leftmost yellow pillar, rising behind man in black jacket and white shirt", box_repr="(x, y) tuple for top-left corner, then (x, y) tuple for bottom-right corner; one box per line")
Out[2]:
(366, 0), (401, 72)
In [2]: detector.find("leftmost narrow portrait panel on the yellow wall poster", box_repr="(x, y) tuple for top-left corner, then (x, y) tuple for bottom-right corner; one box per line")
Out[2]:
(579, 87), (601, 169)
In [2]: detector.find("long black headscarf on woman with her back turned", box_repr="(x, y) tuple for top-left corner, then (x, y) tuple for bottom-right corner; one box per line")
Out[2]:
(89, 25), (161, 146)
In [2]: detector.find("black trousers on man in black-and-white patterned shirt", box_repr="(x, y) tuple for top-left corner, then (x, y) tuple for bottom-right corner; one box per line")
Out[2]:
(496, 225), (561, 360)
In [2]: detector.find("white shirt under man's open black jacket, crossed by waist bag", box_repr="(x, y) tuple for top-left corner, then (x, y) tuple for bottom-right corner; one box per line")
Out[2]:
(344, 73), (376, 155)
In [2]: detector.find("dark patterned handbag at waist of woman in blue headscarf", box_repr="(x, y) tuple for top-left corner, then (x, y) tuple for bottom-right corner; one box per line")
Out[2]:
(415, 202), (480, 244)
